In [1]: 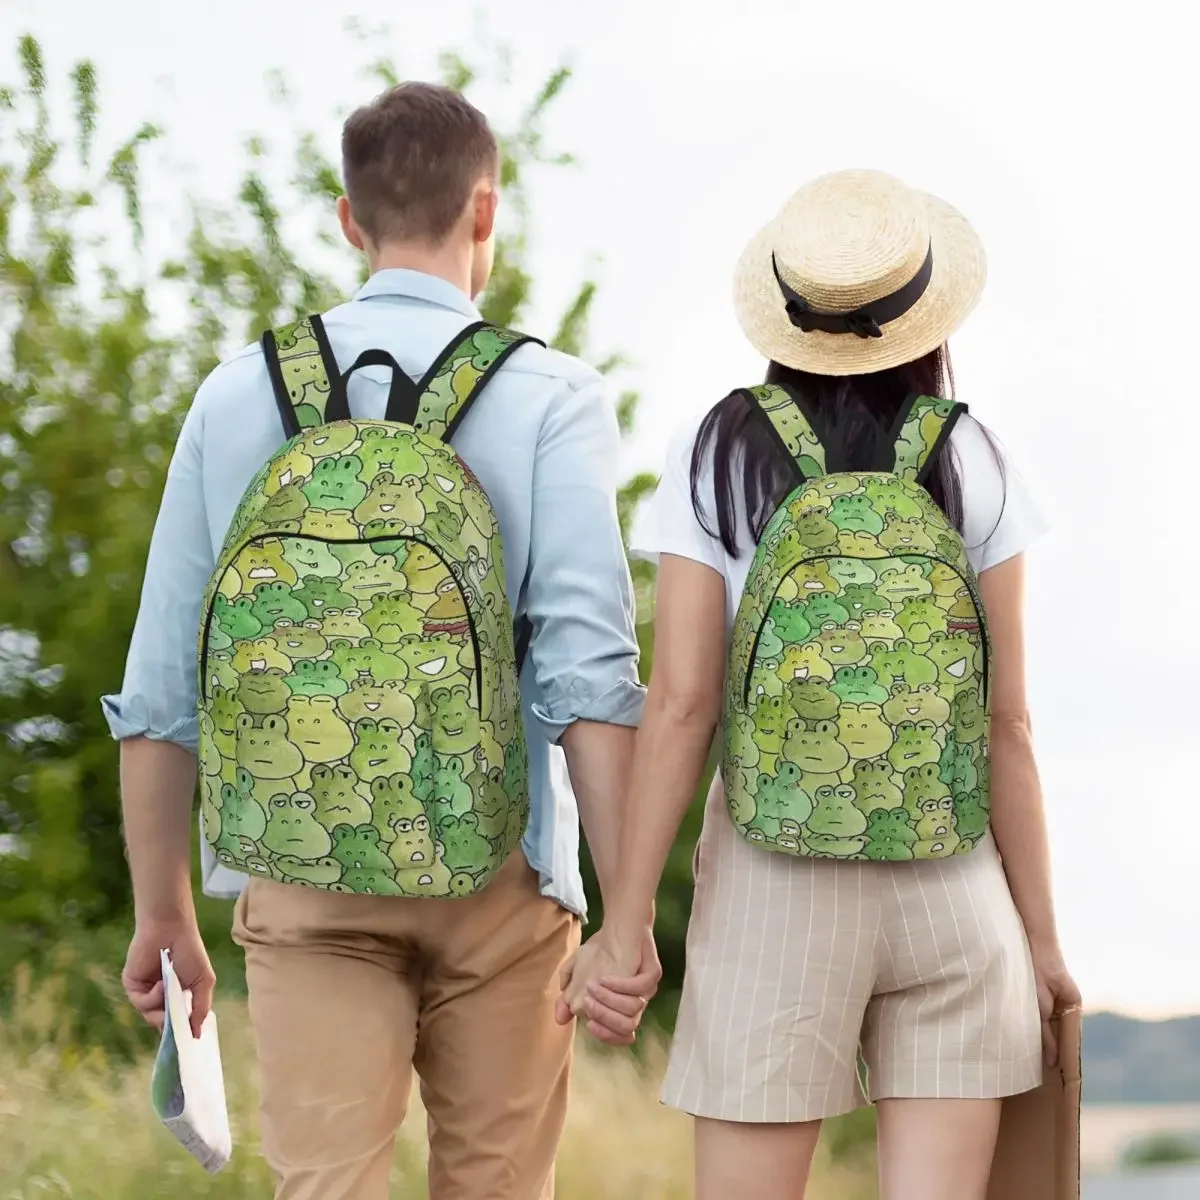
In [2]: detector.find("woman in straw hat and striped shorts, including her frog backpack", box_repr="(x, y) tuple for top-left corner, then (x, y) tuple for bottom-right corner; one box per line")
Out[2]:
(566, 172), (1078, 1200)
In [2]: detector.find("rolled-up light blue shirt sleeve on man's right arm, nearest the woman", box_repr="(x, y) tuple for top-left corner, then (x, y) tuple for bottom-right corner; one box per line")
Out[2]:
(526, 376), (644, 742)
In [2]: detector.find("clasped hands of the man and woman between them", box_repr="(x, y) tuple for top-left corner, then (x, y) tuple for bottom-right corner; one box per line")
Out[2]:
(554, 929), (662, 1046)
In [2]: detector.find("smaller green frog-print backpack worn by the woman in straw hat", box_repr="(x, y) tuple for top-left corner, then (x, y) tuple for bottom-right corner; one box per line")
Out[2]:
(722, 385), (990, 862)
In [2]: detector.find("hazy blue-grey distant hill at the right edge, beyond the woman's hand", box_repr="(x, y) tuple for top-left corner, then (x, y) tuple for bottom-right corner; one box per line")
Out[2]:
(1084, 1013), (1200, 1104)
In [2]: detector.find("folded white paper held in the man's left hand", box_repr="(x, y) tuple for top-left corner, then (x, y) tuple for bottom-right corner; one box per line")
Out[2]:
(150, 950), (233, 1175)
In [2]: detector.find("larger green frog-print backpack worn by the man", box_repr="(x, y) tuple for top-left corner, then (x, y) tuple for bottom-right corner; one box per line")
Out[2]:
(198, 317), (542, 896)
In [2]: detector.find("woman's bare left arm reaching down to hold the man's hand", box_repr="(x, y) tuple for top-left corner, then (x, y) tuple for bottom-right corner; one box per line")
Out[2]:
(565, 554), (726, 1013)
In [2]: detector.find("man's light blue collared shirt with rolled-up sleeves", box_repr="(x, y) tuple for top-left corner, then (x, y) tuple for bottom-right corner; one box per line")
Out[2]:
(103, 269), (643, 916)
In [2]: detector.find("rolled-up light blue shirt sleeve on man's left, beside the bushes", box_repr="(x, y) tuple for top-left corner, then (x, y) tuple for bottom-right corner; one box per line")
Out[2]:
(101, 388), (215, 750)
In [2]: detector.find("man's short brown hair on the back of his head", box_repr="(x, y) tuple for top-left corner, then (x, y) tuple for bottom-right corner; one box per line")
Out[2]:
(342, 83), (499, 245)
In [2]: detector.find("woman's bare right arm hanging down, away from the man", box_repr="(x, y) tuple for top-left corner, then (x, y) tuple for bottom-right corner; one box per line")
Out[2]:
(979, 554), (1079, 1062)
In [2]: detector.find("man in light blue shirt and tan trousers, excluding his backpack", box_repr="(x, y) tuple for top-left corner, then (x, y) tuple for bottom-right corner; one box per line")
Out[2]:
(104, 84), (658, 1200)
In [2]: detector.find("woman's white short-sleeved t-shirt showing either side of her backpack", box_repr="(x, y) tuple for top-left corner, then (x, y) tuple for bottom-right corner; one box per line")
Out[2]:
(634, 415), (1046, 629)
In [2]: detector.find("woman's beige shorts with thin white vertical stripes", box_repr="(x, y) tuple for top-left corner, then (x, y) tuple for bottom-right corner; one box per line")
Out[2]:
(662, 778), (1042, 1122)
